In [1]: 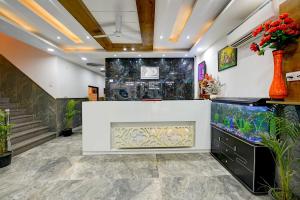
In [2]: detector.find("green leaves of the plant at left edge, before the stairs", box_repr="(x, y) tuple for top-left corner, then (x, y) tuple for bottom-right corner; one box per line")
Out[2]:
(0, 110), (11, 154)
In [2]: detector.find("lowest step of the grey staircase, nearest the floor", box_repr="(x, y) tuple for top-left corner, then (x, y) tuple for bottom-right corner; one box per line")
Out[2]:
(12, 132), (56, 156)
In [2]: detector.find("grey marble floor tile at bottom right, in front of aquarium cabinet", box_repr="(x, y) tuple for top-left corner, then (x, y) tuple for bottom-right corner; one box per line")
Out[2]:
(160, 175), (262, 200)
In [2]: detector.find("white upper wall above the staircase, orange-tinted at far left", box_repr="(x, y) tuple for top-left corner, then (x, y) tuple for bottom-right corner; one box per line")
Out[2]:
(0, 33), (105, 98)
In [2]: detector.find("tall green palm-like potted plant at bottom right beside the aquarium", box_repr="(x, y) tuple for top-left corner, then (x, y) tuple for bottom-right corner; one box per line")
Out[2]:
(261, 110), (300, 200)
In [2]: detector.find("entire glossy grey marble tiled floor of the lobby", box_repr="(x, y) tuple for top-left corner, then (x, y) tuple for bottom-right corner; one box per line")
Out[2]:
(0, 134), (268, 200)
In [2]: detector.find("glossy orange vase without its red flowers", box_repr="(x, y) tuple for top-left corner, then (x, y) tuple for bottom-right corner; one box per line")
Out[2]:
(269, 50), (287, 99)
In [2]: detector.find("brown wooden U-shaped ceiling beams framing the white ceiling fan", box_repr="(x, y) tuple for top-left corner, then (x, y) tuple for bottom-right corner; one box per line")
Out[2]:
(58, 0), (155, 51)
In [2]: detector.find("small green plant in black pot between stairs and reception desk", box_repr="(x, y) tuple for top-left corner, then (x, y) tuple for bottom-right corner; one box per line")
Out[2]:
(61, 99), (79, 137)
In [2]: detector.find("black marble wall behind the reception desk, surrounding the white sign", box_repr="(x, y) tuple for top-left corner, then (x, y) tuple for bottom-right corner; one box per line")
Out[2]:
(105, 58), (194, 101)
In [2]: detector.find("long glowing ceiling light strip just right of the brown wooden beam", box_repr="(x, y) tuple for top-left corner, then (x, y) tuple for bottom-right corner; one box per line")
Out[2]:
(169, 0), (196, 42)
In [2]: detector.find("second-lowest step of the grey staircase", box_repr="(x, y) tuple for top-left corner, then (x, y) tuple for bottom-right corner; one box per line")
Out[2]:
(10, 126), (48, 145)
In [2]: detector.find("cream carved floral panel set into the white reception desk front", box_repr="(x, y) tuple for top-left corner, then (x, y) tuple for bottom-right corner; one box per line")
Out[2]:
(112, 125), (195, 148)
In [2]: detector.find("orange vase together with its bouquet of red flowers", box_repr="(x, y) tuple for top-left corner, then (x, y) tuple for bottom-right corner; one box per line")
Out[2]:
(250, 13), (300, 99)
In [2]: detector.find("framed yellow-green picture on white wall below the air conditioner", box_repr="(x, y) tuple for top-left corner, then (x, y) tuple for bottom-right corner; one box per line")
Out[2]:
(218, 46), (237, 71)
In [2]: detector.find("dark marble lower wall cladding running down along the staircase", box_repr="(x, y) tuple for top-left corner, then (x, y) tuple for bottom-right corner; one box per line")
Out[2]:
(0, 55), (87, 132)
